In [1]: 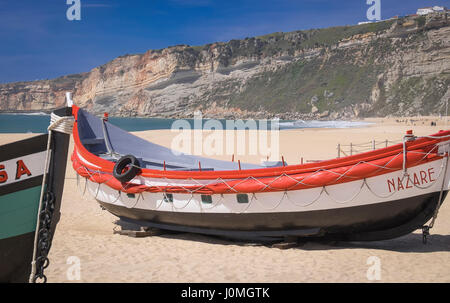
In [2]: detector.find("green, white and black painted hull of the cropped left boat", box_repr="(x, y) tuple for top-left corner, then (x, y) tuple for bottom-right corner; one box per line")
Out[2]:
(0, 109), (71, 282)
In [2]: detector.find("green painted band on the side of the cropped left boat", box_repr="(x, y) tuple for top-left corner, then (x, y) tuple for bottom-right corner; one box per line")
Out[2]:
(0, 186), (41, 240)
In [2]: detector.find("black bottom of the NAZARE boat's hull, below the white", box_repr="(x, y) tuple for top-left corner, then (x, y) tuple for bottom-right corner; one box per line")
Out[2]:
(99, 192), (447, 241)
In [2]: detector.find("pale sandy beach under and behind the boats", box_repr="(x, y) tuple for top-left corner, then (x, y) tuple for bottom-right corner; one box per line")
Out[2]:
(0, 117), (450, 282)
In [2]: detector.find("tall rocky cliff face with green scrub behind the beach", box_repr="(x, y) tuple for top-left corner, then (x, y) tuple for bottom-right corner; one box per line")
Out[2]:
(0, 13), (450, 119)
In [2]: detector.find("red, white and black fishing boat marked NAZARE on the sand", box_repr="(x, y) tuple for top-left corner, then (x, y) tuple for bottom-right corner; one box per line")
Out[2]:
(71, 107), (450, 241)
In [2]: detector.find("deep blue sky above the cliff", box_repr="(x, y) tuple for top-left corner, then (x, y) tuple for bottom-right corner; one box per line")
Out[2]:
(0, 0), (450, 83)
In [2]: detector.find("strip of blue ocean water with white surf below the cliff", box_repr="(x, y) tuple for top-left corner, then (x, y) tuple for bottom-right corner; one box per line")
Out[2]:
(0, 113), (369, 133)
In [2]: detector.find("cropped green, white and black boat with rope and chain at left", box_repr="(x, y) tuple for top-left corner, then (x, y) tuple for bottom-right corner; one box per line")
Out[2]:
(0, 107), (73, 282)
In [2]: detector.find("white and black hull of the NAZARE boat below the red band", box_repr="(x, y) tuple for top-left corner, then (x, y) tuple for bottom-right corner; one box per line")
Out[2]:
(86, 159), (450, 241)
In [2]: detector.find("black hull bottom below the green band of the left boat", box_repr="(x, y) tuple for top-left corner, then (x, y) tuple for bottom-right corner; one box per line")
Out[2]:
(0, 232), (34, 282)
